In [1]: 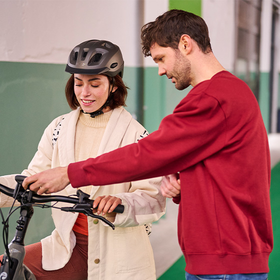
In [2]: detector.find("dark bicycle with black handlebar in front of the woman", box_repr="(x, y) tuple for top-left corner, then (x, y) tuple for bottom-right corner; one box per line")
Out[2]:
(0, 175), (124, 280)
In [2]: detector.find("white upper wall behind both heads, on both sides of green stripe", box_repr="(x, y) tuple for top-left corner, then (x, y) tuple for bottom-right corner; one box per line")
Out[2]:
(0, 0), (238, 70)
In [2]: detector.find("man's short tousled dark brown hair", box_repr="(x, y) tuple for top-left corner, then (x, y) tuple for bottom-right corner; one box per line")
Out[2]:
(141, 9), (212, 56)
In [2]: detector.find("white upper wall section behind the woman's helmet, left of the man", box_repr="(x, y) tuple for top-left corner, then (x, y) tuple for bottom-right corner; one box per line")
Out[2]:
(0, 0), (151, 66)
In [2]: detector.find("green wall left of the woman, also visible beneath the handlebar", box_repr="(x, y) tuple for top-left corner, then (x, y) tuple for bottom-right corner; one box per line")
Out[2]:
(0, 62), (69, 254)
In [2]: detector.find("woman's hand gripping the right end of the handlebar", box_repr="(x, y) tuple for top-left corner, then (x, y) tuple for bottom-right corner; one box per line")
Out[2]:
(93, 195), (122, 217)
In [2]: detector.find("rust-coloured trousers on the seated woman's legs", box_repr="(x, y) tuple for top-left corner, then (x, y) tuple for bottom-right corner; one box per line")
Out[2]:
(0, 232), (88, 280)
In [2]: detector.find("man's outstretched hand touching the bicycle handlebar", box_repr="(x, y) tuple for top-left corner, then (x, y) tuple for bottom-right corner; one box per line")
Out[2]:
(22, 167), (70, 194)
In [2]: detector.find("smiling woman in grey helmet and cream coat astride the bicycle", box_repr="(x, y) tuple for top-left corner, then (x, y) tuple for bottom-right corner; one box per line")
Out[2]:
(0, 40), (165, 280)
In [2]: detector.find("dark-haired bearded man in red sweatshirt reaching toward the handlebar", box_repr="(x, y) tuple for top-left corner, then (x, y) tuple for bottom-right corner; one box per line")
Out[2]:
(24, 10), (273, 280)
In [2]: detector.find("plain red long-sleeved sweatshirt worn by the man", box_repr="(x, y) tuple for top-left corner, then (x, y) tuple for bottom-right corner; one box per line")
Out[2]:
(68, 71), (273, 274)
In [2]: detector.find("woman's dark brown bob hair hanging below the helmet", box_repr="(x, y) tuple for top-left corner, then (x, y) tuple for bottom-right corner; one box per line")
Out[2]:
(65, 74), (128, 110)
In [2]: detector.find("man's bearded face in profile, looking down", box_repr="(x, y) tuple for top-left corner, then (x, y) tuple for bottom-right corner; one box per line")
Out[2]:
(150, 43), (191, 90)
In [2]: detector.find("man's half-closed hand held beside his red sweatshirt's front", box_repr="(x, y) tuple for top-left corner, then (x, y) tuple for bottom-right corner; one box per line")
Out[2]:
(160, 174), (181, 198)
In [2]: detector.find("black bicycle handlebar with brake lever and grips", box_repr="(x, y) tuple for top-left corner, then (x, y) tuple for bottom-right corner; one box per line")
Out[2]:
(0, 175), (124, 229)
